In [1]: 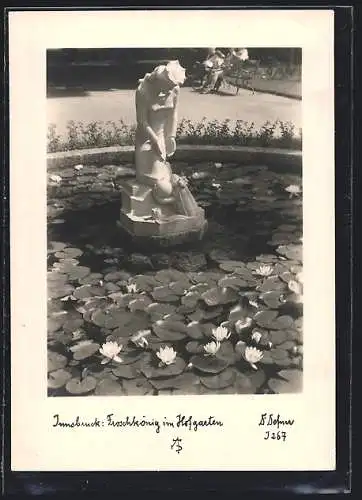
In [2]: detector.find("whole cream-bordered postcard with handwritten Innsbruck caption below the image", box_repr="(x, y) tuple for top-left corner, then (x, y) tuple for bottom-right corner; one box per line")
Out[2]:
(9, 8), (336, 472)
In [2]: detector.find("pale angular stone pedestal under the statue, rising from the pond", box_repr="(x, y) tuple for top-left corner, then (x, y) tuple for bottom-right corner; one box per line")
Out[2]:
(119, 180), (207, 246)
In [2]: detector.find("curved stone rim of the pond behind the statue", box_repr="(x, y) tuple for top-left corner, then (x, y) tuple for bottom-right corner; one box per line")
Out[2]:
(47, 145), (302, 173)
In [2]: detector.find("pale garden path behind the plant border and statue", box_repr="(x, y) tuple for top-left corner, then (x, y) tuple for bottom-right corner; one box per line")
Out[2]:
(47, 87), (302, 135)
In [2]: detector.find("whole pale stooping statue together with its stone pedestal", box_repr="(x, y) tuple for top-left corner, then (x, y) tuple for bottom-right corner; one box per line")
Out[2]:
(120, 61), (206, 243)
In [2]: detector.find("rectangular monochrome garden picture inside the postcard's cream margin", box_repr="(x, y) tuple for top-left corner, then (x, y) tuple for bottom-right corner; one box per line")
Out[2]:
(46, 46), (303, 396)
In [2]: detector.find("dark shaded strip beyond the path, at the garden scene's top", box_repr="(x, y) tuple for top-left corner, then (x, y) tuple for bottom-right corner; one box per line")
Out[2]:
(47, 47), (302, 88)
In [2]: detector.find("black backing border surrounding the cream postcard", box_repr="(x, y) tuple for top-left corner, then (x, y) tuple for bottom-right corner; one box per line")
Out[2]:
(2, 6), (353, 494)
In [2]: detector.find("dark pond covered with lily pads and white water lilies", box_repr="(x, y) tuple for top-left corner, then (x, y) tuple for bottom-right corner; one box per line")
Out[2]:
(47, 162), (303, 396)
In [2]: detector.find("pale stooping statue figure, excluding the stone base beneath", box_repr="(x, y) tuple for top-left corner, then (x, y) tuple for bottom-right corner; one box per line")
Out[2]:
(135, 61), (200, 216)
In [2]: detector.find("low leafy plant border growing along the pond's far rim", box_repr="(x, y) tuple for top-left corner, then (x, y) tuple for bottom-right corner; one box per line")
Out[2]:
(47, 117), (302, 153)
